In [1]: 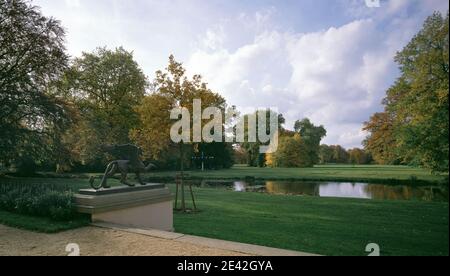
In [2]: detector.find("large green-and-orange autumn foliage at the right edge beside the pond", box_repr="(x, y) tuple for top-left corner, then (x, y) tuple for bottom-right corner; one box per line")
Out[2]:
(366, 13), (449, 172)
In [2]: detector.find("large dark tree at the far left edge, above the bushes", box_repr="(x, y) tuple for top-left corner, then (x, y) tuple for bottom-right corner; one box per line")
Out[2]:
(0, 0), (71, 172)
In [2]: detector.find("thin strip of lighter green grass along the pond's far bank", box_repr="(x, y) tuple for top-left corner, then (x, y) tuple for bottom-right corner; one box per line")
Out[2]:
(145, 165), (448, 184)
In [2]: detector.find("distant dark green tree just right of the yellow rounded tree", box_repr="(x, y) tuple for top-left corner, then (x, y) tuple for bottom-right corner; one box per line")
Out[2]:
(294, 118), (327, 165)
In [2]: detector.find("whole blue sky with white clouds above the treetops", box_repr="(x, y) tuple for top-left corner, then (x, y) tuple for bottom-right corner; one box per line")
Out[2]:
(32, 0), (449, 148)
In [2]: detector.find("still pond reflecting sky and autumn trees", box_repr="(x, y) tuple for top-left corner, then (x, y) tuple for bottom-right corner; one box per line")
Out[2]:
(185, 180), (449, 202)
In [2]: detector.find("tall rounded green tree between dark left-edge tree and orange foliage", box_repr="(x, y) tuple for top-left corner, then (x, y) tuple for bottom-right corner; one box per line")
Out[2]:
(61, 48), (148, 167)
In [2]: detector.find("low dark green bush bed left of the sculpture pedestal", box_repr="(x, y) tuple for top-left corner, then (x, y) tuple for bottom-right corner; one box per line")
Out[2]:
(0, 181), (77, 221)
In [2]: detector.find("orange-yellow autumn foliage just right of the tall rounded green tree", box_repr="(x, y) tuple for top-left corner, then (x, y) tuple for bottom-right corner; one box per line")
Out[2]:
(130, 56), (232, 167)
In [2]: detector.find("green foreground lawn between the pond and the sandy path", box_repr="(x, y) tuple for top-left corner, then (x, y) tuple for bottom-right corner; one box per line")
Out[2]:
(172, 187), (449, 255)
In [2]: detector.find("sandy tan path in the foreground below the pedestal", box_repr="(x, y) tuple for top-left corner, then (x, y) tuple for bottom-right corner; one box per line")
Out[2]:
(0, 225), (246, 256)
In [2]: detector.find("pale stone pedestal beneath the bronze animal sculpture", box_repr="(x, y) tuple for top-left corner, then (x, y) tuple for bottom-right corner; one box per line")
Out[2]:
(75, 184), (173, 231)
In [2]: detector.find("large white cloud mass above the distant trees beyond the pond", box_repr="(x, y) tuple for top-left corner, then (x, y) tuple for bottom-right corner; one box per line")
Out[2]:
(187, 20), (396, 147)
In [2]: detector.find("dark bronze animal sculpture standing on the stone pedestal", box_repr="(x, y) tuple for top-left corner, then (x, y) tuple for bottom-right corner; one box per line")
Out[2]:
(89, 144), (156, 190)
